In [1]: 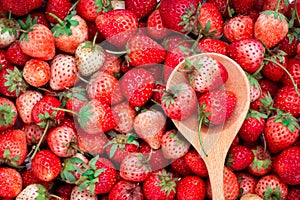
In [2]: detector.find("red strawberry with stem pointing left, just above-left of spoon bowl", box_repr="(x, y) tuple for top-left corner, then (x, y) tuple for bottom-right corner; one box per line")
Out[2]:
(127, 34), (166, 67)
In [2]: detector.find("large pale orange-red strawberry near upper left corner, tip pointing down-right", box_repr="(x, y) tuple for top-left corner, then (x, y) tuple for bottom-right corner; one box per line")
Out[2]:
(20, 23), (55, 60)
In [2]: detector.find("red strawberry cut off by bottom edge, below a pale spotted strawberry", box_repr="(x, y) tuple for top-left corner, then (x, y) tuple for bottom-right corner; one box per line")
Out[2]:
(108, 180), (144, 200)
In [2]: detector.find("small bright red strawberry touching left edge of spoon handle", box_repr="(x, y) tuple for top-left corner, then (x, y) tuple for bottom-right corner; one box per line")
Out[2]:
(184, 149), (208, 177)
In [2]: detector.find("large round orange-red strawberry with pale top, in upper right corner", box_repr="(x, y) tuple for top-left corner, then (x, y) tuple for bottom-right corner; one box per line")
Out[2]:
(254, 10), (288, 48)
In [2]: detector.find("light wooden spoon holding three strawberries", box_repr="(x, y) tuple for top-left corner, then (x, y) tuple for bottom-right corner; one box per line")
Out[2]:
(166, 53), (250, 200)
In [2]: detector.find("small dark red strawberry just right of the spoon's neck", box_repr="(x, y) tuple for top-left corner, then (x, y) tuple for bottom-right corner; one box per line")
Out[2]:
(226, 145), (254, 171)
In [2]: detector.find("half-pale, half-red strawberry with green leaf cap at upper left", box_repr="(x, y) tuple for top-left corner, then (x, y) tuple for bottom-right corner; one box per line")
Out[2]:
(52, 13), (88, 54)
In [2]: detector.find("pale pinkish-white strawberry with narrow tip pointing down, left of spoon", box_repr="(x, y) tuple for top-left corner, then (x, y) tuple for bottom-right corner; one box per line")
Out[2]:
(133, 110), (166, 149)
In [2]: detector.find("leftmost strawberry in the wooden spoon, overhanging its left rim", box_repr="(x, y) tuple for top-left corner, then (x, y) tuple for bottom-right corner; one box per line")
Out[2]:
(161, 83), (197, 120)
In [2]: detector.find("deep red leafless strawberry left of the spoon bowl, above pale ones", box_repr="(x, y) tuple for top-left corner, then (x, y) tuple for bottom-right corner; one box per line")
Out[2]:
(120, 68), (154, 107)
